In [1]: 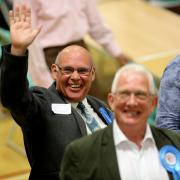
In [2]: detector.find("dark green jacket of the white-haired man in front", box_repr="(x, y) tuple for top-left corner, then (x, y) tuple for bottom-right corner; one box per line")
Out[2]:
(61, 126), (180, 180)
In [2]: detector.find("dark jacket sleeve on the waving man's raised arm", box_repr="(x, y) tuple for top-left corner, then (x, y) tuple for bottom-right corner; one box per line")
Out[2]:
(0, 46), (46, 127)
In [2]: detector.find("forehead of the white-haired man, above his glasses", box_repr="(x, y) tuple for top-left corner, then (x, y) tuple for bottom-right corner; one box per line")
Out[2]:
(117, 71), (150, 91)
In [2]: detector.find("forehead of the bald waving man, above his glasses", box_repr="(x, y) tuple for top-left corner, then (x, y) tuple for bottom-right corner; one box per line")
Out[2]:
(59, 49), (92, 67)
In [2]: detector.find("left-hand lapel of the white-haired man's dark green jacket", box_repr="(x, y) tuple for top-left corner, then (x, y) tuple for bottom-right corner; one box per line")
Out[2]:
(101, 125), (121, 180)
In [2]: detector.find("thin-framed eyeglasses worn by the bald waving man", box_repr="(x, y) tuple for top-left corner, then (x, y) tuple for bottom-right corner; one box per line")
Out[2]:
(56, 64), (92, 76)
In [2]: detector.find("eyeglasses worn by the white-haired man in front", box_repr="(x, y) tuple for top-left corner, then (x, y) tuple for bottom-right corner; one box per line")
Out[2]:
(115, 90), (152, 101)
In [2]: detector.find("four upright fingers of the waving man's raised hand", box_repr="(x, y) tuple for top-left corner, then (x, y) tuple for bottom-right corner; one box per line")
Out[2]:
(9, 5), (31, 25)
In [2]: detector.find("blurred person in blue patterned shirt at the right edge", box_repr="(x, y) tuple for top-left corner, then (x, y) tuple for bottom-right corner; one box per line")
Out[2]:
(155, 56), (180, 133)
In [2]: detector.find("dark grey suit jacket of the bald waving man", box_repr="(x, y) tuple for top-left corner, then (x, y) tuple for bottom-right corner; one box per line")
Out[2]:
(0, 47), (111, 180)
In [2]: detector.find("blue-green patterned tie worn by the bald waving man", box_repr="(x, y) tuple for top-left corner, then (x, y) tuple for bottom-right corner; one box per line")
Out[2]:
(77, 102), (100, 132)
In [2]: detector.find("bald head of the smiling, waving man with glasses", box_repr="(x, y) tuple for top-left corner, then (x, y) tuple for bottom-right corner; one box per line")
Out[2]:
(51, 45), (95, 102)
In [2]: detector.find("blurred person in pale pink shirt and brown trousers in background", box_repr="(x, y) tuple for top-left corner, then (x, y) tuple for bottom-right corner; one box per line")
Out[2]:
(14, 0), (131, 90)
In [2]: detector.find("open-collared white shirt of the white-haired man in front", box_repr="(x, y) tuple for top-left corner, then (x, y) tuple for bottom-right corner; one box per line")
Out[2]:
(113, 120), (169, 180)
